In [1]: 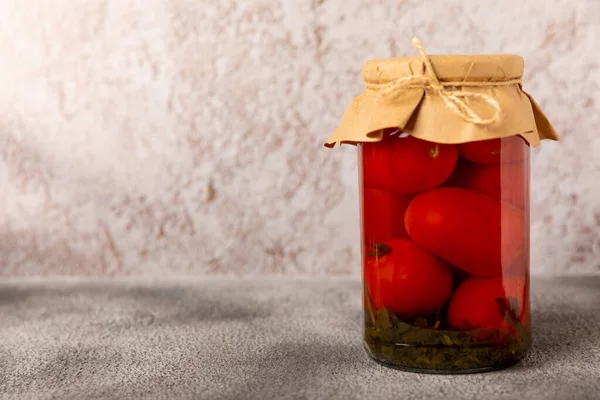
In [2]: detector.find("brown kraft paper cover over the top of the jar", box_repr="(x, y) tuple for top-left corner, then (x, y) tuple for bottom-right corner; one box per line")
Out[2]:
(325, 54), (559, 147)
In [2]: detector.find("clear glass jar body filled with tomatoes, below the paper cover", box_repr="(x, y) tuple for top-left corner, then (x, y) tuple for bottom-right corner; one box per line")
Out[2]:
(358, 131), (530, 373)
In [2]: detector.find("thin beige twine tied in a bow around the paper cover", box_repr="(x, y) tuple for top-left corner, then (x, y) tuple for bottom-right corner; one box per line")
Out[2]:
(366, 37), (521, 125)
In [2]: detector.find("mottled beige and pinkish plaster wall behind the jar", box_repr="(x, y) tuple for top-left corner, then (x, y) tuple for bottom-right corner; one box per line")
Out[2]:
(0, 0), (600, 276)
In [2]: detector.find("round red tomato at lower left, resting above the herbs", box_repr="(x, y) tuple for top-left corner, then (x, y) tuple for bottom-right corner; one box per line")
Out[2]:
(365, 239), (452, 316)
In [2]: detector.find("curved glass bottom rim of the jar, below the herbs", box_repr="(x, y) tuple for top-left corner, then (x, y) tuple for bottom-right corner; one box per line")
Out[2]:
(363, 342), (526, 375)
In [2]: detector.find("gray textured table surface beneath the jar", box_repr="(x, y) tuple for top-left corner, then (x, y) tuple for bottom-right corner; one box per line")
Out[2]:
(0, 277), (600, 400)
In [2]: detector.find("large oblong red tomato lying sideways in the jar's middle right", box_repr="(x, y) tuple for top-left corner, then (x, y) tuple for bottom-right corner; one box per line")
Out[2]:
(404, 187), (528, 276)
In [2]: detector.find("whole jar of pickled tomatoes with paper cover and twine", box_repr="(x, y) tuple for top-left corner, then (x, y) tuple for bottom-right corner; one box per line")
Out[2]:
(326, 39), (558, 373)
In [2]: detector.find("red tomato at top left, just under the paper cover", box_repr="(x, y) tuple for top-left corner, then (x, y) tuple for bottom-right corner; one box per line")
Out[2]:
(362, 136), (458, 194)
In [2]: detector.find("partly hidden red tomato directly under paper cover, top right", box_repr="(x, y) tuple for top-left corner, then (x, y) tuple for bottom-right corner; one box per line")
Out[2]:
(458, 136), (529, 164)
